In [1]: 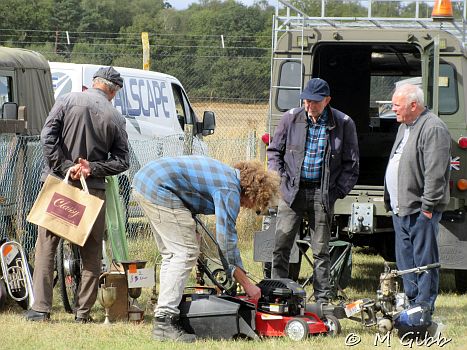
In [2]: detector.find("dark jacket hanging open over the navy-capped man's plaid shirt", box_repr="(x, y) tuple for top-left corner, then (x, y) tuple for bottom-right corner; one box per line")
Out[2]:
(267, 106), (359, 213)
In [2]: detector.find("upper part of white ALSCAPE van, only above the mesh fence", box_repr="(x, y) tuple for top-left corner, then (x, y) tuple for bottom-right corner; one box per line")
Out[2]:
(49, 62), (215, 146)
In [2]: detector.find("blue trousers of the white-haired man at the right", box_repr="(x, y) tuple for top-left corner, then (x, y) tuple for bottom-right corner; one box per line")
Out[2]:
(392, 212), (441, 311)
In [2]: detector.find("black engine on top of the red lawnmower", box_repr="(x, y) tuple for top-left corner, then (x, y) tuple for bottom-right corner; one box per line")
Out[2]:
(258, 279), (306, 316)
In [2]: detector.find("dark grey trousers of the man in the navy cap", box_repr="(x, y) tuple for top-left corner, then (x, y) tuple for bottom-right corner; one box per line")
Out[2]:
(272, 188), (331, 301)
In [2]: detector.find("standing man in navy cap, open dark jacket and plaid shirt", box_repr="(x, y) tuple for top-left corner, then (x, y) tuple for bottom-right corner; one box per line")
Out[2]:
(267, 78), (359, 304)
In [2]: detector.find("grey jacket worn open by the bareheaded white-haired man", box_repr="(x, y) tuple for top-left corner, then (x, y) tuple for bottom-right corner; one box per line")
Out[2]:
(384, 109), (451, 216)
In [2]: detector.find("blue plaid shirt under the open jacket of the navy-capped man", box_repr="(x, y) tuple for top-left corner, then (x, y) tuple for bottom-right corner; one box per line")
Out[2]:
(300, 109), (328, 182)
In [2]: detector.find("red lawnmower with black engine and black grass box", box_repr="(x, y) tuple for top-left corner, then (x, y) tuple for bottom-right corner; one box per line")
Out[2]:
(179, 220), (341, 341)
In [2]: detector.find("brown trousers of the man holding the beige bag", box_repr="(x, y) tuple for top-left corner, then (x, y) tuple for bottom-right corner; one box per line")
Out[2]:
(32, 188), (105, 318)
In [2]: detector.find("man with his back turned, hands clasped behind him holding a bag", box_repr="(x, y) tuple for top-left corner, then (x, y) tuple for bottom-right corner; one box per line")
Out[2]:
(26, 67), (129, 323)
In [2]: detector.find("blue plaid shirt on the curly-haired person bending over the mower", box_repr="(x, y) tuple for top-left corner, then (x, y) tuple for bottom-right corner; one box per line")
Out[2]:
(133, 156), (243, 275)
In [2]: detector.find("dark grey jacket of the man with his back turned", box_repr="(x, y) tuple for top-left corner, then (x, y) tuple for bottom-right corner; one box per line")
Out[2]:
(41, 89), (130, 189)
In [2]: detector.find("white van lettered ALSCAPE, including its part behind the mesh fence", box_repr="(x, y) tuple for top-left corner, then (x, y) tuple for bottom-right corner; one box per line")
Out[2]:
(49, 62), (215, 227)
